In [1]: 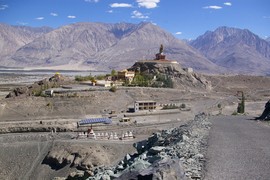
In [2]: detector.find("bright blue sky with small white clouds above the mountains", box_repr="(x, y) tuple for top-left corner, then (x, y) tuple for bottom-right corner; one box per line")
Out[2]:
(0, 0), (270, 39)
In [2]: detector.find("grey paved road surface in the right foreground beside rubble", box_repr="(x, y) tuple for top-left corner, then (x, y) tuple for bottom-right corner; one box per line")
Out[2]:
(205, 116), (270, 180)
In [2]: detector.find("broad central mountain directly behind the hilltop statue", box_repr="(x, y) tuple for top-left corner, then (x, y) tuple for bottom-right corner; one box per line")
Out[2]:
(0, 23), (218, 71)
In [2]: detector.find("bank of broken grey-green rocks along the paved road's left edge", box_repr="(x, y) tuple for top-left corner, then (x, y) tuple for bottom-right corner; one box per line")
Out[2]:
(64, 113), (211, 180)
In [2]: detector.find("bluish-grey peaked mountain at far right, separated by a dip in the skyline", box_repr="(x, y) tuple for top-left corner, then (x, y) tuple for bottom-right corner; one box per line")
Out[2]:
(190, 27), (270, 73)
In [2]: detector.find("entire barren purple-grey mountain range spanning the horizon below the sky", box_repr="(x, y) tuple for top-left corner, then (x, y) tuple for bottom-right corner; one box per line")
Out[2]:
(0, 22), (270, 74)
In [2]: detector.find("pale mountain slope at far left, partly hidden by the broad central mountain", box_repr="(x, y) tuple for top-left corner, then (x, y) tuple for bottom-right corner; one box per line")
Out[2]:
(0, 24), (52, 64)
